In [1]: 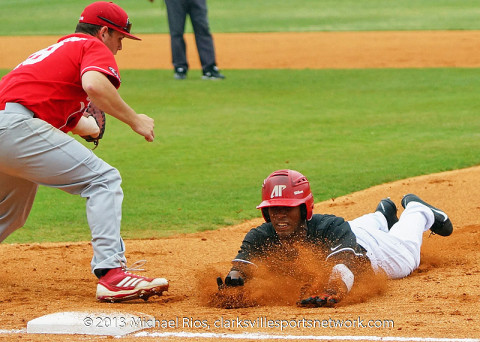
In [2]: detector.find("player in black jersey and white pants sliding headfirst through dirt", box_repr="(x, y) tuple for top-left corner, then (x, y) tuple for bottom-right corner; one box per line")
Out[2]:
(217, 170), (453, 307)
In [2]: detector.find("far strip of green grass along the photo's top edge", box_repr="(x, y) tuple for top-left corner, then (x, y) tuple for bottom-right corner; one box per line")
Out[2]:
(0, 0), (480, 35)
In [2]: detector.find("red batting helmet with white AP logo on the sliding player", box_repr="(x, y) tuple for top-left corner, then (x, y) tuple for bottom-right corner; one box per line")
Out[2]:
(257, 170), (313, 222)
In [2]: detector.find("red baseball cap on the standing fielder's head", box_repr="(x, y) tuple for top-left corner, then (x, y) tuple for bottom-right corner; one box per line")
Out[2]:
(78, 1), (141, 40)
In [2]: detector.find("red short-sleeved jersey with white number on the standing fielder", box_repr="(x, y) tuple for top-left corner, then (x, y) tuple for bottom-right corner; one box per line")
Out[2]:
(0, 33), (121, 132)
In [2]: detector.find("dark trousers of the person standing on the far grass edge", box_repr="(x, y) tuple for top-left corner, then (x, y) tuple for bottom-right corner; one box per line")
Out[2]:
(165, 0), (216, 69)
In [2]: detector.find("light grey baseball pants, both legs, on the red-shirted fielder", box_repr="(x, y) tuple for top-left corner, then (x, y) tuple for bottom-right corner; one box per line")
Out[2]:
(0, 103), (125, 272)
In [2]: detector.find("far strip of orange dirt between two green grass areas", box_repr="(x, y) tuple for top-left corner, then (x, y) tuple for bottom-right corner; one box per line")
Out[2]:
(0, 31), (480, 69)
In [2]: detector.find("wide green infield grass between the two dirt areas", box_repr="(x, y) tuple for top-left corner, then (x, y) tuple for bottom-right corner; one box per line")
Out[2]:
(3, 69), (480, 242)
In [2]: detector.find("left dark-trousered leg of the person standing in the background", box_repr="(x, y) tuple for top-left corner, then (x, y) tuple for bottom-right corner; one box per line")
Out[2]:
(165, 0), (188, 70)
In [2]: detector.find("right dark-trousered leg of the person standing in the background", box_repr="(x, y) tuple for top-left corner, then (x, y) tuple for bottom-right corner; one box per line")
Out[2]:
(190, 0), (217, 70)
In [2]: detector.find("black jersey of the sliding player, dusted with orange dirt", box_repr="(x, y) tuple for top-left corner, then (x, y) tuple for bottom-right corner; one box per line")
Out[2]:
(233, 214), (369, 273)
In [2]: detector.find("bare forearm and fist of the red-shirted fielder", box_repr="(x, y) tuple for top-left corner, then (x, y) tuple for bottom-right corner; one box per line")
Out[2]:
(82, 71), (155, 142)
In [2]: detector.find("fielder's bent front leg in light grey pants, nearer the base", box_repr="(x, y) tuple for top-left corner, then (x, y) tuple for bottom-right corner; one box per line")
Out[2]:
(0, 107), (125, 271)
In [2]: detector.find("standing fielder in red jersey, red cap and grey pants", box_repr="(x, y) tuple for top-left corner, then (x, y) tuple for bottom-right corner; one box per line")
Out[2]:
(0, 1), (168, 301)
